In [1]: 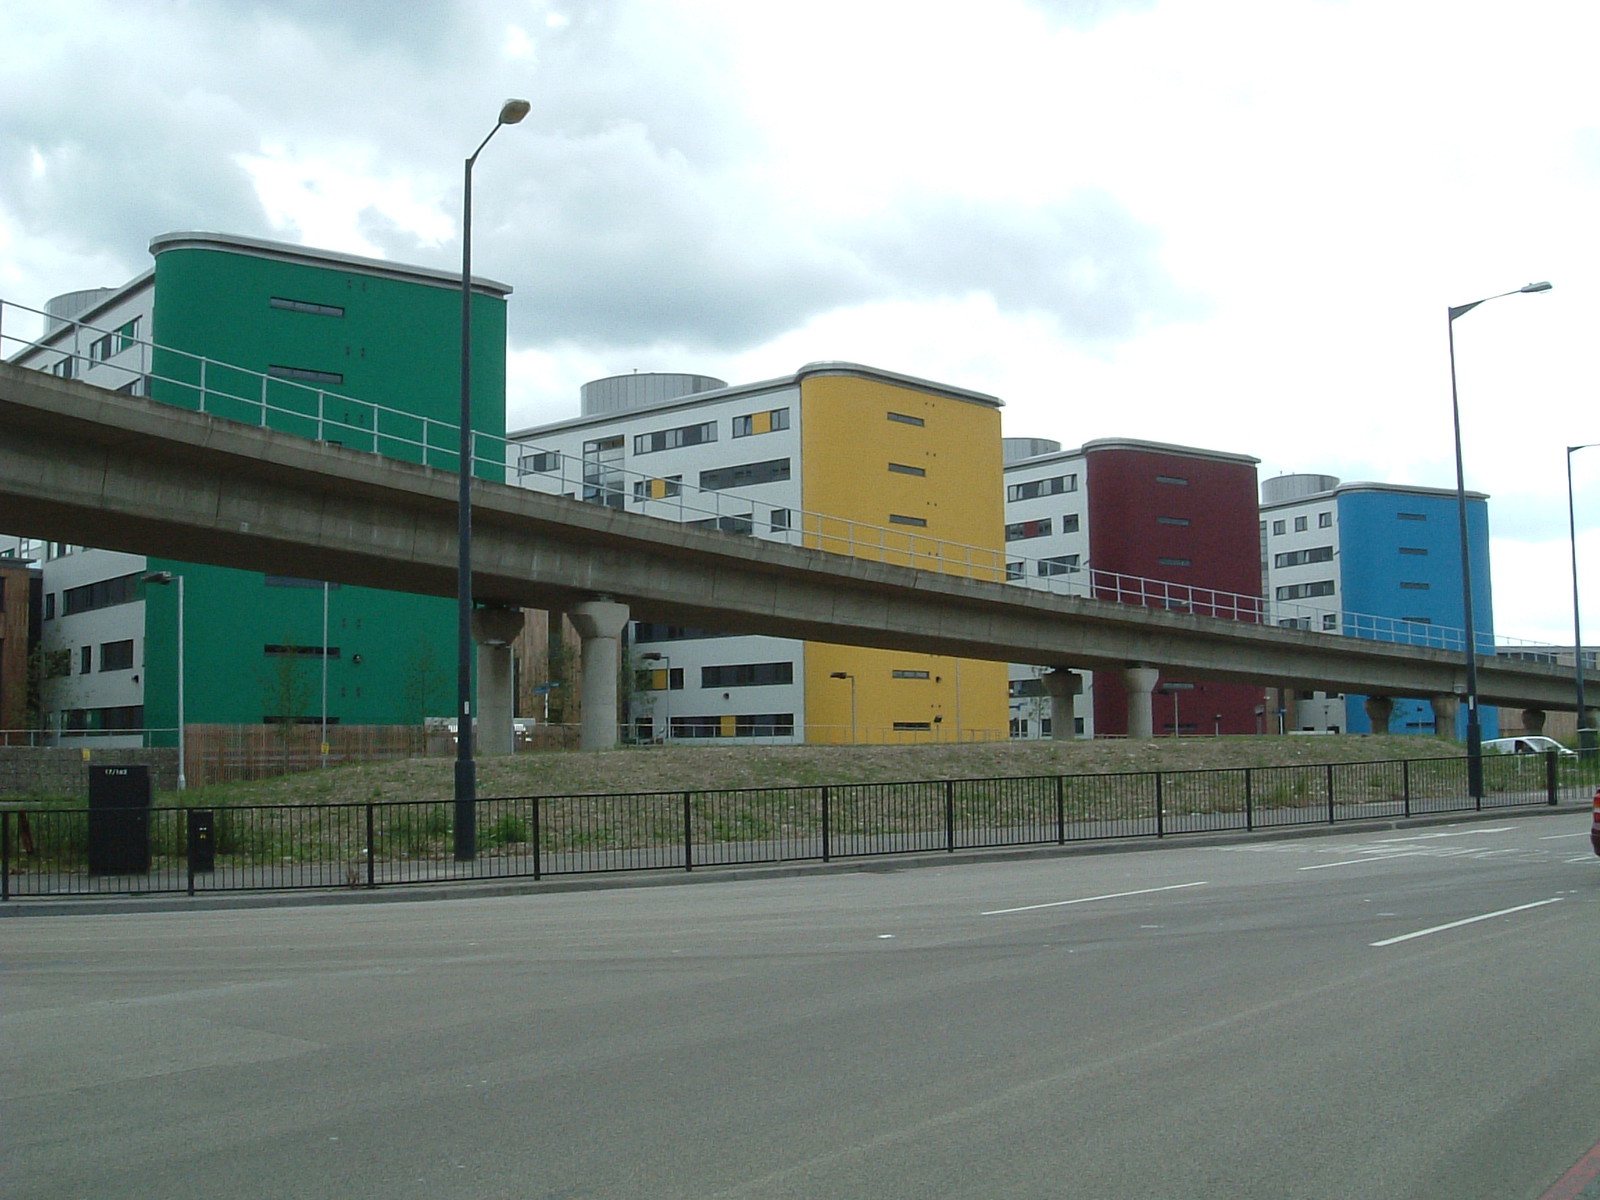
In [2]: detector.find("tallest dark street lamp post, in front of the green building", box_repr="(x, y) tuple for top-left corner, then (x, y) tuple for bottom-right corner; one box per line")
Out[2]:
(454, 99), (530, 862)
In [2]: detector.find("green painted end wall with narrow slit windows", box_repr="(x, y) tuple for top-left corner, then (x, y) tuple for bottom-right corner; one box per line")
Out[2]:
(144, 248), (506, 739)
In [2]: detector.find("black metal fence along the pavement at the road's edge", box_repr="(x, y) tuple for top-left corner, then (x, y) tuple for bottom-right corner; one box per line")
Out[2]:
(0, 755), (1574, 899)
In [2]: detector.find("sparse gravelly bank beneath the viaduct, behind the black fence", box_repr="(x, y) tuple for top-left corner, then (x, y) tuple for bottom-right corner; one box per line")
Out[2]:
(172, 736), (1462, 805)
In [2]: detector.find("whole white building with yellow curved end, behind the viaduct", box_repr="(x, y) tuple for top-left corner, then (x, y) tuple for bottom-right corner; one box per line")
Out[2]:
(509, 363), (1006, 744)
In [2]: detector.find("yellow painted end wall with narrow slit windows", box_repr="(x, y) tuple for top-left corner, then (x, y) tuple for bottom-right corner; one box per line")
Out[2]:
(800, 374), (1010, 742)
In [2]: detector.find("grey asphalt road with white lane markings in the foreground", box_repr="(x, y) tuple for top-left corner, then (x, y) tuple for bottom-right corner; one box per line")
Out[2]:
(0, 811), (1600, 1200)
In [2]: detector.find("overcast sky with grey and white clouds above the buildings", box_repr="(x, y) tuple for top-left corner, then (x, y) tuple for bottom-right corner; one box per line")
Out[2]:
(0, 0), (1600, 643)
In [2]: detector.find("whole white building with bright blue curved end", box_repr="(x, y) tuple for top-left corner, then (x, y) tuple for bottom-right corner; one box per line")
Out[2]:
(1261, 475), (1499, 739)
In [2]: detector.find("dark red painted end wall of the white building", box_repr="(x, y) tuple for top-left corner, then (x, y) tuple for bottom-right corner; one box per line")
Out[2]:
(1083, 443), (1262, 736)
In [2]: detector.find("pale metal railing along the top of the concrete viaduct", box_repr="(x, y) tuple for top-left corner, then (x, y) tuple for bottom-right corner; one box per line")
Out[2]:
(0, 299), (1547, 654)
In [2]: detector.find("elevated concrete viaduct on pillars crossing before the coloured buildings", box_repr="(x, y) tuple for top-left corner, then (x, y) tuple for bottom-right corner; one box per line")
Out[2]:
(0, 363), (1600, 746)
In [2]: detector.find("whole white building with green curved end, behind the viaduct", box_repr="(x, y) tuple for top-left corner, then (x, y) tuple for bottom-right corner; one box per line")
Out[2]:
(10, 234), (510, 744)
